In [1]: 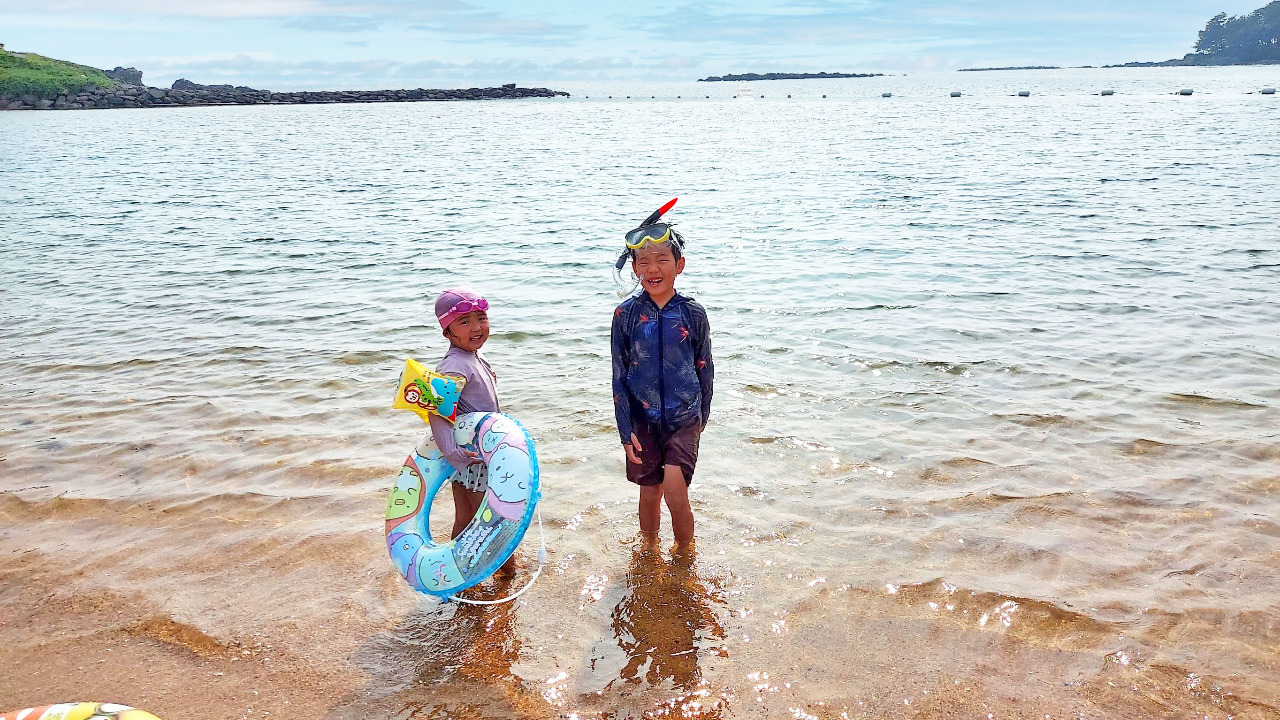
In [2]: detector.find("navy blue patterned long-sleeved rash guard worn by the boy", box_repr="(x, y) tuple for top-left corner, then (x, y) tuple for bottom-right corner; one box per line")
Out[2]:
(612, 292), (716, 445)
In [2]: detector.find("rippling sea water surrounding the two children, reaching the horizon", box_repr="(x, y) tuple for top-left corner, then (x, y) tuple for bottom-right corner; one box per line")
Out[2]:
(0, 68), (1280, 719)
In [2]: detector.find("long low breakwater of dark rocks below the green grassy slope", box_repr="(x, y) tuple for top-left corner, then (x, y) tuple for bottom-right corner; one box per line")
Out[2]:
(0, 73), (568, 110)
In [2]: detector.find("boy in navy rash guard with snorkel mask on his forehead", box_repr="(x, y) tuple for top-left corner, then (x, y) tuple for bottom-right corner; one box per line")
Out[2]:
(612, 204), (714, 546)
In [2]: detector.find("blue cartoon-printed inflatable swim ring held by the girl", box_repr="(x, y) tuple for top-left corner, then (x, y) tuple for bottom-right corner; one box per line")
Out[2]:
(387, 368), (541, 600)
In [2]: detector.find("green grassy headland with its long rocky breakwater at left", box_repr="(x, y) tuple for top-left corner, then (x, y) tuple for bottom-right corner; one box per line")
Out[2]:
(0, 44), (568, 110)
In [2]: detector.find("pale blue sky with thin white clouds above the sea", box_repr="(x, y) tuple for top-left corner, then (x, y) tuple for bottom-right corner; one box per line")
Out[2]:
(0, 0), (1266, 91)
